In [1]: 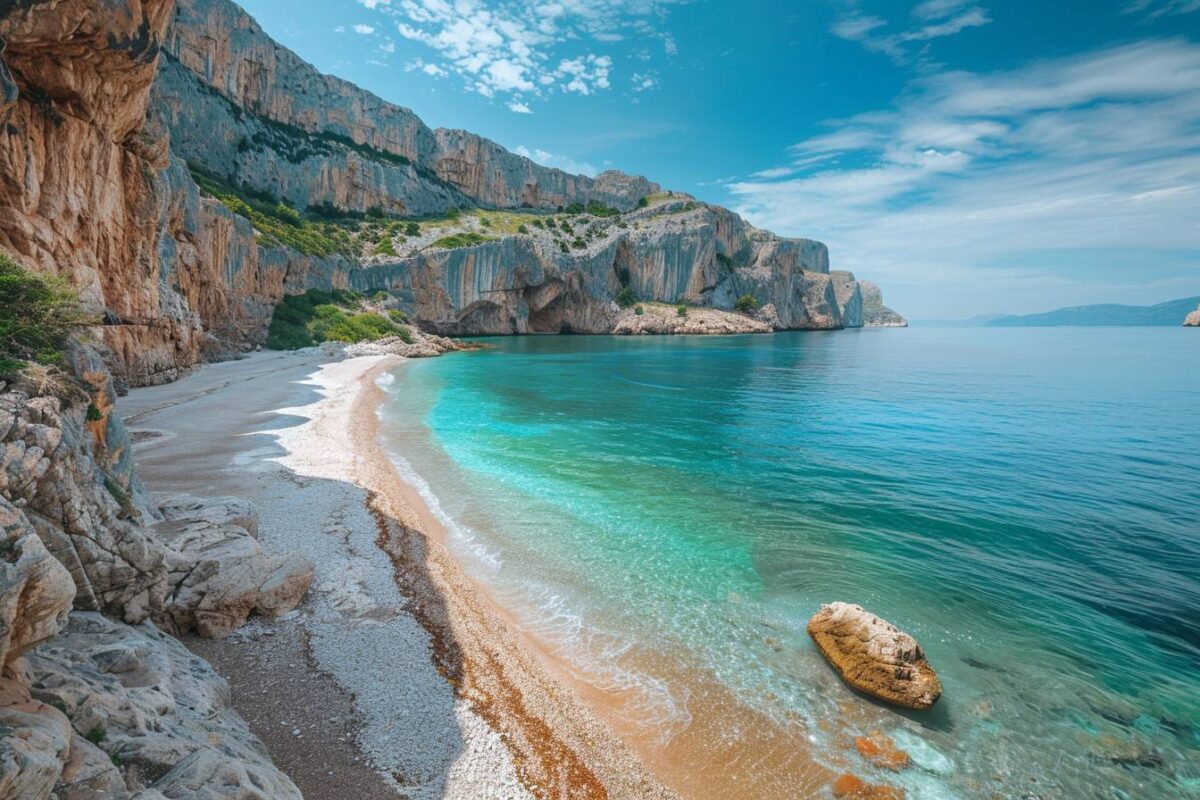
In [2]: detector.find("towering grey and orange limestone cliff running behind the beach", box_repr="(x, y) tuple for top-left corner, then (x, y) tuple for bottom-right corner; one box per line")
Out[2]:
(0, 0), (902, 385)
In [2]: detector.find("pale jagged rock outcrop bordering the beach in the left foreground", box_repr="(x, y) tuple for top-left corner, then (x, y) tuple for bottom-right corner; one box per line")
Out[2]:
(0, 348), (313, 800)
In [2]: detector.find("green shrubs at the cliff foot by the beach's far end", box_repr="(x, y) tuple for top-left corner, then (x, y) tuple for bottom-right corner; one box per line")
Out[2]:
(266, 289), (412, 350)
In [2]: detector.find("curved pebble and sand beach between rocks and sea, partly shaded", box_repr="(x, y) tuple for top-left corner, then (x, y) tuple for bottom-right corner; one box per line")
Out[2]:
(122, 351), (677, 800)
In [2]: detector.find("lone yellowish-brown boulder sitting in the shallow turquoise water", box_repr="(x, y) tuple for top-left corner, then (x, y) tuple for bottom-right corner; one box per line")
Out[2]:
(809, 603), (942, 709)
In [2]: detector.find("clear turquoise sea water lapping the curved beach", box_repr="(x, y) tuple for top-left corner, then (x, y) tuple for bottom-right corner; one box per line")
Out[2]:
(382, 329), (1200, 799)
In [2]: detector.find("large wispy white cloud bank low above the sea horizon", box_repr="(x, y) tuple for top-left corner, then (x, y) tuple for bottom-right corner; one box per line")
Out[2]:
(728, 41), (1200, 315)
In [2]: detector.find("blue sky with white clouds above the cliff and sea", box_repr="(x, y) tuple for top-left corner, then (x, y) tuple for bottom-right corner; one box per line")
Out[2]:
(241, 0), (1200, 319)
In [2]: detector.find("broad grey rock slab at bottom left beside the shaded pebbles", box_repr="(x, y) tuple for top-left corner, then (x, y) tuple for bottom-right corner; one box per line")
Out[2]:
(25, 612), (300, 800)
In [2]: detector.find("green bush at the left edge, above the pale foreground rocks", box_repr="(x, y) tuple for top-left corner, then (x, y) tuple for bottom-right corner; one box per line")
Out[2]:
(0, 253), (97, 378)
